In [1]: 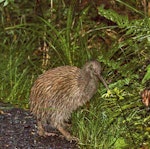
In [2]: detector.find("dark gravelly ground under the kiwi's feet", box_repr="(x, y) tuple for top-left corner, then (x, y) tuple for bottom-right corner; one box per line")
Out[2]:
(0, 103), (77, 149)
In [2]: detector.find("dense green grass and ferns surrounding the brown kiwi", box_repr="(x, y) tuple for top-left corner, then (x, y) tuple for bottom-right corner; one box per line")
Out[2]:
(0, 0), (150, 149)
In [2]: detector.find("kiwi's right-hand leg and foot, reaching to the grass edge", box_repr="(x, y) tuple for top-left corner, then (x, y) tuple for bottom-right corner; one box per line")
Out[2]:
(57, 125), (78, 142)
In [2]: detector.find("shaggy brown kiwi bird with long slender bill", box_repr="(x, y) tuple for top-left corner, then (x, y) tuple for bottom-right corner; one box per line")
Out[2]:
(30, 61), (108, 141)
